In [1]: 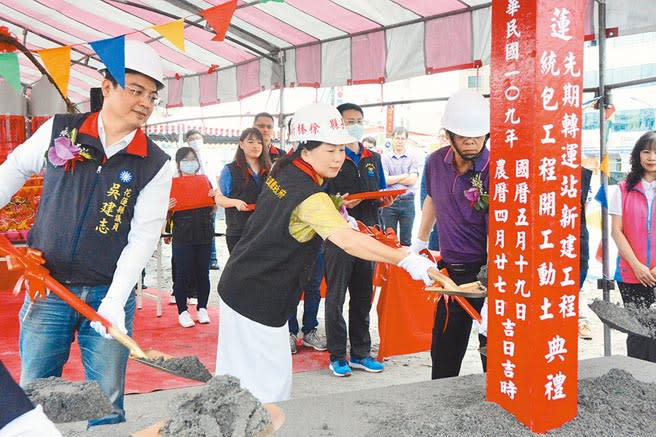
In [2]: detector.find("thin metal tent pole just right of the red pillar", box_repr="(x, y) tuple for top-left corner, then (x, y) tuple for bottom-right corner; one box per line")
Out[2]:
(597, 0), (612, 356)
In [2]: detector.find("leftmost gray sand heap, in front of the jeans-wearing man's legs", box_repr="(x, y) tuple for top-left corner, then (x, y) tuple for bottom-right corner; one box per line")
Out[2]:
(25, 376), (114, 423)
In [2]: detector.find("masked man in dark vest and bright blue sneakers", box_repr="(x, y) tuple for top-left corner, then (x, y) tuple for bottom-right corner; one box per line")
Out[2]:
(324, 103), (387, 376)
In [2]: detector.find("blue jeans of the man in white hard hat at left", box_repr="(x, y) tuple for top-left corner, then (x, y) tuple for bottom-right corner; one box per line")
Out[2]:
(19, 285), (136, 426)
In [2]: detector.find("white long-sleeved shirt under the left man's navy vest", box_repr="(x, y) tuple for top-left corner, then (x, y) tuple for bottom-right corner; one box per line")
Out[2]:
(0, 114), (173, 302)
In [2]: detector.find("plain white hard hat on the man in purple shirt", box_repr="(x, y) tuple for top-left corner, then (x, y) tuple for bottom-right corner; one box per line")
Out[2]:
(442, 90), (490, 137)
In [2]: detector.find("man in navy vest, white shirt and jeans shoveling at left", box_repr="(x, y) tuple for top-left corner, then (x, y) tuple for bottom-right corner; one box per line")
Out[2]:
(0, 40), (172, 426)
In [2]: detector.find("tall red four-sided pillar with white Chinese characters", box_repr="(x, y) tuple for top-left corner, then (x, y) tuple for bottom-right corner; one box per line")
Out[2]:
(487, 0), (585, 433)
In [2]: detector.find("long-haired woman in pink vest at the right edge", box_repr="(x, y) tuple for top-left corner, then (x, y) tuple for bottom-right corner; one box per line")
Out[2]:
(608, 131), (656, 362)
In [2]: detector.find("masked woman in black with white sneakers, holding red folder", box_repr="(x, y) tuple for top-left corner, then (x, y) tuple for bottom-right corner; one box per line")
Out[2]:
(169, 147), (214, 328)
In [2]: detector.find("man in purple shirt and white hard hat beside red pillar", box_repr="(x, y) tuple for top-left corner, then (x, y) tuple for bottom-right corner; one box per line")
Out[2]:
(411, 90), (490, 379)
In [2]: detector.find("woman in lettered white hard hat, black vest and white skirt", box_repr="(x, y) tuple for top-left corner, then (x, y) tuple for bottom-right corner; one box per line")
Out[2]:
(216, 103), (438, 403)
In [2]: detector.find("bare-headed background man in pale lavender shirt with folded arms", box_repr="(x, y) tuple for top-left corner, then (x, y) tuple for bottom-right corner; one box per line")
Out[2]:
(381, 127), (419, 246)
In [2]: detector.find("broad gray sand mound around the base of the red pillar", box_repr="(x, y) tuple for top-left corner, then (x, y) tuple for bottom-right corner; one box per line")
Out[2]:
(370, 369), (656, 437)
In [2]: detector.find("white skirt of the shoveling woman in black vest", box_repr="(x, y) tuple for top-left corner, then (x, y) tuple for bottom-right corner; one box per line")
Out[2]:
(216, 299), (292, 403)
